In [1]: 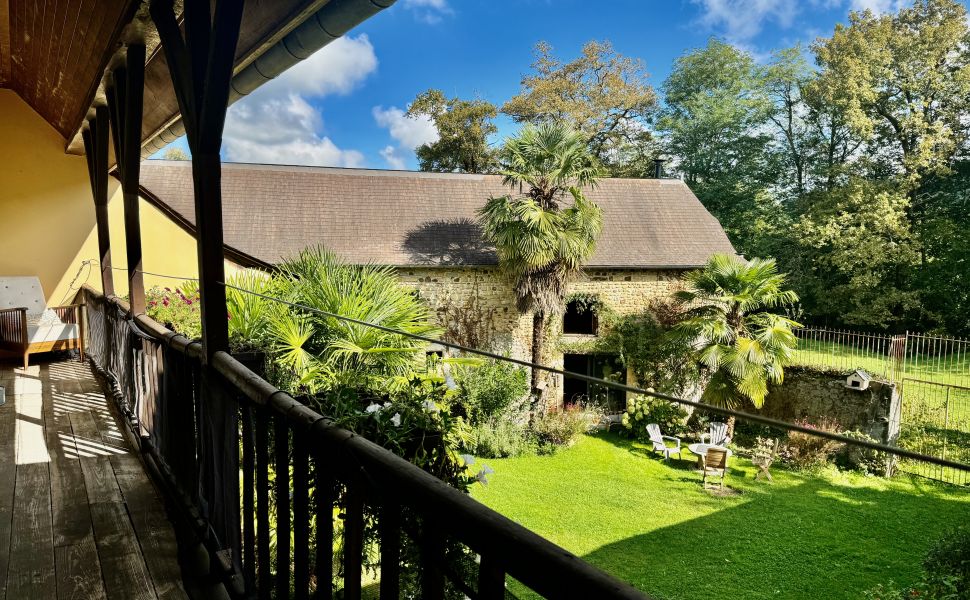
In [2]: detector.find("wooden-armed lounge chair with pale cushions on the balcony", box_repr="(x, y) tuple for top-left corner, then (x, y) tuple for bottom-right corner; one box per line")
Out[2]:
(0, 277), (84, 369)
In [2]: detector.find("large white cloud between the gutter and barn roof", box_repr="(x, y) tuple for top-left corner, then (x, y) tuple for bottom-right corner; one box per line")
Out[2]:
(223, 35), (377, 167)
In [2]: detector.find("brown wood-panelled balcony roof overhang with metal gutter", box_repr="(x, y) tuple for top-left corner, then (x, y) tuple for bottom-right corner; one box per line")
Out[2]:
(0, 0), (394, 157)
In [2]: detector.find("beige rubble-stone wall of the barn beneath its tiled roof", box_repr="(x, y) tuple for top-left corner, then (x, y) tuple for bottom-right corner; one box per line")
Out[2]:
(398, 267), (683, 402)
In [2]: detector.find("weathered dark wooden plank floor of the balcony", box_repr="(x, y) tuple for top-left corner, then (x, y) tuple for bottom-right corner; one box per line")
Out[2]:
(0, 361), (187, 600)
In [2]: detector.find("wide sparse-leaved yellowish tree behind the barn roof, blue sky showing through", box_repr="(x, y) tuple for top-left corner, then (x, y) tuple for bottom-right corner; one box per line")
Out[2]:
(502, 41), (657, 176)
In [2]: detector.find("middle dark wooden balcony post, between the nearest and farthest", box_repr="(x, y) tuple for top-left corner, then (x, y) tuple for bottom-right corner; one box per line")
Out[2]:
(106, 44), (145, 316)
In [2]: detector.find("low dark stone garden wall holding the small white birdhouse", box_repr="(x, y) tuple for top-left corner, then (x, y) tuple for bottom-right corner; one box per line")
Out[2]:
(757, 367), (900, 442)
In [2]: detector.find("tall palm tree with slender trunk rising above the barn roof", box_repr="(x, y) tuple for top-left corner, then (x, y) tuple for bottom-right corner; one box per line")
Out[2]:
(479, 123), (602, 405)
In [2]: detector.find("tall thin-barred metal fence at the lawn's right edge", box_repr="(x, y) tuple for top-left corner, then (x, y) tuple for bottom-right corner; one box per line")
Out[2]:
(793, 328), (970, 485)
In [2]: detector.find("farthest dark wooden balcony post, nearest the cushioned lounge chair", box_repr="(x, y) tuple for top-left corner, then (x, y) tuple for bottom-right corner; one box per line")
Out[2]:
(82, 106), (115, 296)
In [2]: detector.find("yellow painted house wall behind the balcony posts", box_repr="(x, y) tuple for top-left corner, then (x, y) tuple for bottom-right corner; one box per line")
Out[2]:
(0, 90), (239, 305)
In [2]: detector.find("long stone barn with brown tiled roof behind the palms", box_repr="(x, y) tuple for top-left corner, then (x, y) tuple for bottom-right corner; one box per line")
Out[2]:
(141, 161), (735, 403)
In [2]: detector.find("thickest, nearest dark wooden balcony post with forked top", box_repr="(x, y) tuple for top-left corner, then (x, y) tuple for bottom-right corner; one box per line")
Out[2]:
(149, 0), (246, 573)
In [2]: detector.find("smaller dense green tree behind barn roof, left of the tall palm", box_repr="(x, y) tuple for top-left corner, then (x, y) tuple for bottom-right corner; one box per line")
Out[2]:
(407, 89), (498, 173)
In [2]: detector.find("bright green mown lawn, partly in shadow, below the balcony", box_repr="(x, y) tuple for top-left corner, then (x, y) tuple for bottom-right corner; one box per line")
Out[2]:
(473, 435), (970, 600)
